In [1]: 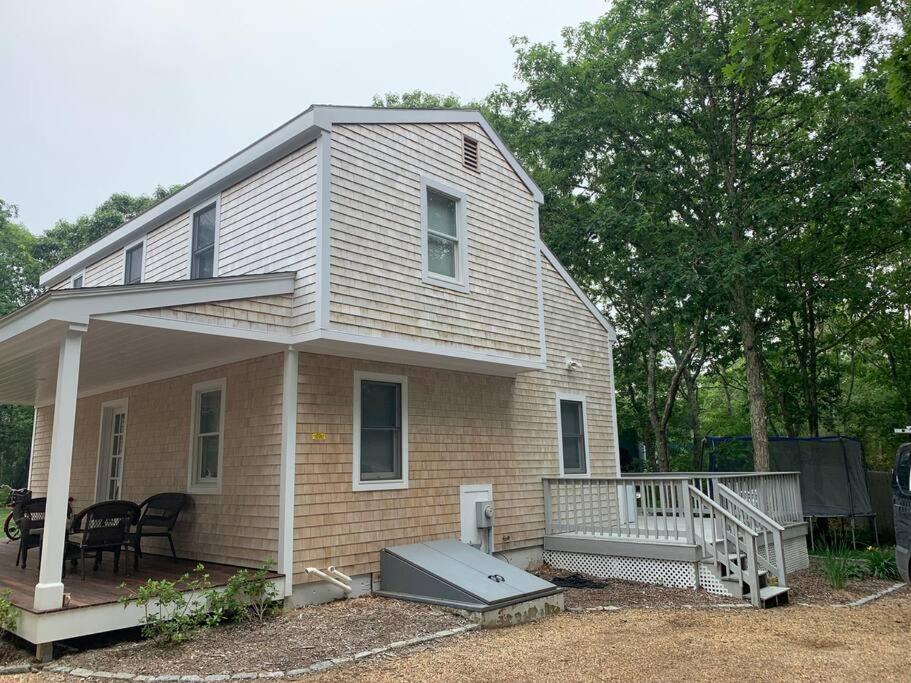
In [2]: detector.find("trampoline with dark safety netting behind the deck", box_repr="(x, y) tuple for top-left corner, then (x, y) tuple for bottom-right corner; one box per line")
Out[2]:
(705, 436), (879, 547)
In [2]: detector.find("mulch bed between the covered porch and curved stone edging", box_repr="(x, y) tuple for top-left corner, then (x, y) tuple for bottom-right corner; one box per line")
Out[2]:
(55, 598), (468, 676)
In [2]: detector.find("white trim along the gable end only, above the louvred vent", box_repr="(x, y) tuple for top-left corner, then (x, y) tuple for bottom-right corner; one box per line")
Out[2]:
(313, 105), (544, 204)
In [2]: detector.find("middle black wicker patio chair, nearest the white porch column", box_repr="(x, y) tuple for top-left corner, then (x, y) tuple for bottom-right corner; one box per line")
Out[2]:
(64, 500), (139, 580)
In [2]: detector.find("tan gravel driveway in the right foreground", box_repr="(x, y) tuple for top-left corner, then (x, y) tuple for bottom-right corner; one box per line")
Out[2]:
(306, 587), (911, 683)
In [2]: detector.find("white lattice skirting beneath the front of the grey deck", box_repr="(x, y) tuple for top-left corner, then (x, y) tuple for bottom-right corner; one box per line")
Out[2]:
(544, 550), (730, 595)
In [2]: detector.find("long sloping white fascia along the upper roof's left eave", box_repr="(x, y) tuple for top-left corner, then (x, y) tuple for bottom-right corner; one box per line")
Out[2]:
(39, 107), (319, 287)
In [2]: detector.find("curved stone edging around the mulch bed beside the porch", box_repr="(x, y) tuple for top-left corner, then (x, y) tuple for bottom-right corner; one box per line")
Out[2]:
(37, 624), (480, 683)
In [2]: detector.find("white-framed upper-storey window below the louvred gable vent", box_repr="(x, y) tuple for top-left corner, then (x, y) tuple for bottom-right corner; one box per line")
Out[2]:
(421, 177), (468, 292)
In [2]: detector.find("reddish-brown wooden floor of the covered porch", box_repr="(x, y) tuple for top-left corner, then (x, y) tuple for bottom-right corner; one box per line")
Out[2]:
(0, 541), (281, 614)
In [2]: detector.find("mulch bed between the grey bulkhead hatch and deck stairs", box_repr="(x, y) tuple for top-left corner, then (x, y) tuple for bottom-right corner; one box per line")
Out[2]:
(536, 567), (742, 609)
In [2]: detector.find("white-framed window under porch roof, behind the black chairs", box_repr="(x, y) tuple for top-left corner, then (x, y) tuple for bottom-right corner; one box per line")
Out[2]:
(188, 378), (225, 493)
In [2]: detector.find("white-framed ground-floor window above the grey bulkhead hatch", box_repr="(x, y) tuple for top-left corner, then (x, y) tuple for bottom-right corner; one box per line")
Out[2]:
(352, 372), (408, 491)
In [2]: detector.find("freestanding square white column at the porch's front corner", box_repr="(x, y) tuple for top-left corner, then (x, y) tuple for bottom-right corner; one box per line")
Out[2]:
(35, 324), (88, 610)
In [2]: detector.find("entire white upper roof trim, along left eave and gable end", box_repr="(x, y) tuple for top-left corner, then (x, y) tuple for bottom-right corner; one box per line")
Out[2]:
(39, 105), (544, 287)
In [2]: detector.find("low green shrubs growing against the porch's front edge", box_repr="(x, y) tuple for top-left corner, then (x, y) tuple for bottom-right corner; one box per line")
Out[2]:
(120, 560), (281, 645)
